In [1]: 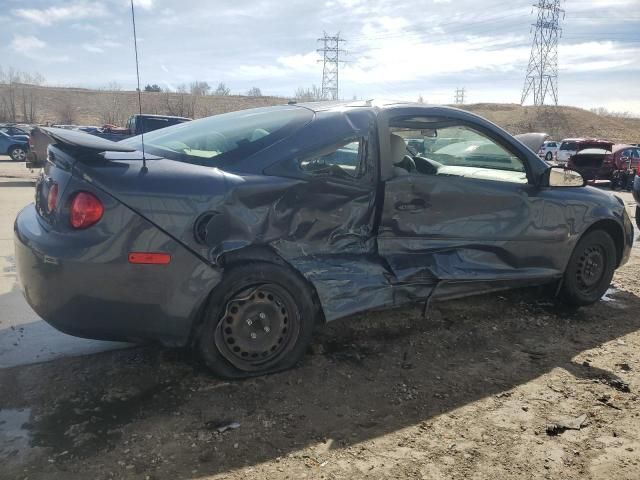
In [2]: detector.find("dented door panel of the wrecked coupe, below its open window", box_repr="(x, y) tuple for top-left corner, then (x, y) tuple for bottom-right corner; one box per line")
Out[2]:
(378, 175), (559, 282)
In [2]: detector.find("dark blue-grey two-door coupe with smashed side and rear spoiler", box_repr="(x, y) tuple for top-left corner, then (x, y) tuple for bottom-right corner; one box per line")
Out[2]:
(15, 102), (633, 378)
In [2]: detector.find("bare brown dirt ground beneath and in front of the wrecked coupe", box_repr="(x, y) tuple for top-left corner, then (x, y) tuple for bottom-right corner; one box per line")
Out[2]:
(0, 162), (640, 480)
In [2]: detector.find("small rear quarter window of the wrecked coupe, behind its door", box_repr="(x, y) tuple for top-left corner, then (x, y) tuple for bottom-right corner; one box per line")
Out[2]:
(299, 138), (367, 178)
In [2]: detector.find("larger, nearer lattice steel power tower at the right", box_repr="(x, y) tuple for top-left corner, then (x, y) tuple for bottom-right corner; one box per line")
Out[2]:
(520, 0), (564, 105)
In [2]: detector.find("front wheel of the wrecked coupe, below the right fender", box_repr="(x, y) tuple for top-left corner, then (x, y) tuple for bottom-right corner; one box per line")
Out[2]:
(561, 230), (616, 306)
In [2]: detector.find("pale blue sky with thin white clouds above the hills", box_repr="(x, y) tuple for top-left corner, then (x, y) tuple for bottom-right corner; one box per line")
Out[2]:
(0, 0), (640, 115)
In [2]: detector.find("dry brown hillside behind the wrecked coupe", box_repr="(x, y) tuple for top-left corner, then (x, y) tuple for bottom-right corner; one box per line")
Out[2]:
(0, 85), (640, 143)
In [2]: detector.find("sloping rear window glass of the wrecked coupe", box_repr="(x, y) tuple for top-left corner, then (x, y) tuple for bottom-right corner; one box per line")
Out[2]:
(121, 106), (313, 166)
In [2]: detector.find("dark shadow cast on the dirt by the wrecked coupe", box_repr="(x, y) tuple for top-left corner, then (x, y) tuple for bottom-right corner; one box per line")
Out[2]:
(0, 289), (640, 478)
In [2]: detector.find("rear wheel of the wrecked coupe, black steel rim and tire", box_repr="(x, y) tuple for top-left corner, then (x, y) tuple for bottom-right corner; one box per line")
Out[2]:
(197, 262), (319, 379)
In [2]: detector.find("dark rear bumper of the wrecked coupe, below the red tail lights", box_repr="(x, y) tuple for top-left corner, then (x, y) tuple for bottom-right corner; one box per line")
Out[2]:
(14, 204), (220, 346)
